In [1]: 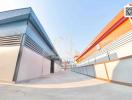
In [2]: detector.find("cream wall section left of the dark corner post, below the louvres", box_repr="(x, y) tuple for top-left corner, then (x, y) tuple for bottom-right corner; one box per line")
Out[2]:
(0, 46), (20, 82)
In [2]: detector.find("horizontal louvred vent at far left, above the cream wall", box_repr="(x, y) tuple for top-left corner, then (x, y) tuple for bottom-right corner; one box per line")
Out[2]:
(0, 35), (21, 46)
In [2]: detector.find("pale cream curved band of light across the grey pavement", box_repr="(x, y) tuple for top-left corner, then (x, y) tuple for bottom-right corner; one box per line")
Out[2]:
(0, 79), (108, 89)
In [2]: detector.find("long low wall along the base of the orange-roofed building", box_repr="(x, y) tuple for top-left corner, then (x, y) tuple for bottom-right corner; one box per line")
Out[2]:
(75, 58), (132, 84)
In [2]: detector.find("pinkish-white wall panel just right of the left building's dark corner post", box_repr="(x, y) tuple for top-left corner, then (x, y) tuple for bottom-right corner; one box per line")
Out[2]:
(17, 47), (43, 81)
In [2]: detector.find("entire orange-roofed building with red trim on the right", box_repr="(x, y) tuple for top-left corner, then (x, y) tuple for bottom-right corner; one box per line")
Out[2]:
(72, 5), (132, 85)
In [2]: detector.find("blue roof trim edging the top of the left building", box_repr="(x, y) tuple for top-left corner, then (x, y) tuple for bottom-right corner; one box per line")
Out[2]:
(0, 7), (59, 56)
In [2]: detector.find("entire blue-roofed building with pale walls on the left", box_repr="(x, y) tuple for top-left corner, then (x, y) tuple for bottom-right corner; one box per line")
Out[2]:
(0, 8), (61, 82)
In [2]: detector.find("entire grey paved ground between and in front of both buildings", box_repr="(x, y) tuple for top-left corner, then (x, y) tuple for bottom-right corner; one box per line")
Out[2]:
(0, 72), (132, 100)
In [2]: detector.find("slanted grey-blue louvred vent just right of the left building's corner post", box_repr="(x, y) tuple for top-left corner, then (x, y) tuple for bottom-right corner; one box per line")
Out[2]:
(24, 35), (43, 54)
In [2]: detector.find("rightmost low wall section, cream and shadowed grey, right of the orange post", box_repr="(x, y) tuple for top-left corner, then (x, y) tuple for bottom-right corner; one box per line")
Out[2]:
(106, 58), (132, 84)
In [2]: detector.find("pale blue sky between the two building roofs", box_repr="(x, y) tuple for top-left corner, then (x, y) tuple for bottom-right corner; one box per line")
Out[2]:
(0, 0), (132, 60)
